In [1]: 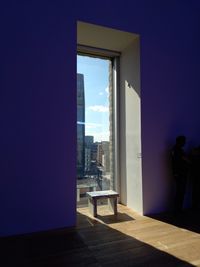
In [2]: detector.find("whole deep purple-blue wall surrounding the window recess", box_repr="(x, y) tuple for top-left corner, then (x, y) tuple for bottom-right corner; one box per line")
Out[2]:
(0, 0), (200, 236)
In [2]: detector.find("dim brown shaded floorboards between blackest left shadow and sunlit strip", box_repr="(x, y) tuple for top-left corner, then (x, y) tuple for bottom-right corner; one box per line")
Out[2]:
(77, 212), (194, 267)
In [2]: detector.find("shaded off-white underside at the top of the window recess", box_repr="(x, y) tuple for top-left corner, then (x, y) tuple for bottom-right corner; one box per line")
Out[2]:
(77, 21), (139, 52)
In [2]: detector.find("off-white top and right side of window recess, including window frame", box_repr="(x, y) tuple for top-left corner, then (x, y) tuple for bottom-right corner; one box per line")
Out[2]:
(77, 21), (144, 214)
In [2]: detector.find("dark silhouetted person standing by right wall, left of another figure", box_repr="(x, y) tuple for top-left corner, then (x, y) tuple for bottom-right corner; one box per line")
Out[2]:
(171, 135), (188, 212)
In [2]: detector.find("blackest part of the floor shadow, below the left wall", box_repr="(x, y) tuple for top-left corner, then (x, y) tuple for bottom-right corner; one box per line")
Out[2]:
(0, 228), (98, 267)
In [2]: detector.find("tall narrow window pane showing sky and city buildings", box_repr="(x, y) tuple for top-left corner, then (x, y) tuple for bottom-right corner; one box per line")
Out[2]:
(77, 55), (114, 206)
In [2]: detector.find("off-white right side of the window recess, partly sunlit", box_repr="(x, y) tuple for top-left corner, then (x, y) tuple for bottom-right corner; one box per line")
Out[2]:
(120, 37), (143, 213)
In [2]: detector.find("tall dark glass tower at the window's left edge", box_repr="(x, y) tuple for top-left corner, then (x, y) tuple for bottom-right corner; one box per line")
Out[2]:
(77, 73), (85, 179)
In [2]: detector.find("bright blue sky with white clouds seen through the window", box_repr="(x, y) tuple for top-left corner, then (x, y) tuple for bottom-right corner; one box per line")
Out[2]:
(77, 55), (109, 142)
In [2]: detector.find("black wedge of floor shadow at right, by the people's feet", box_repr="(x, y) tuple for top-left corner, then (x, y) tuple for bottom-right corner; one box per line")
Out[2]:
(148, 209), (200, 233)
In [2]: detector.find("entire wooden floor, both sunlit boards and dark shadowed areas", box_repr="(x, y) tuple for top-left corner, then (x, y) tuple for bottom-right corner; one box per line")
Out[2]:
(0, 205), (200, 267)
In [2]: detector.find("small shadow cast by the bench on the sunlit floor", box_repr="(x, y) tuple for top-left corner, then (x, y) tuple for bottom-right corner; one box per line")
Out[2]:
(94, 212), (135, 224)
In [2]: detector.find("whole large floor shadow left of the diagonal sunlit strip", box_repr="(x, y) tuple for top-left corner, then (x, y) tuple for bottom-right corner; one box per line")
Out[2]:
(0, 213), (197, 267)
